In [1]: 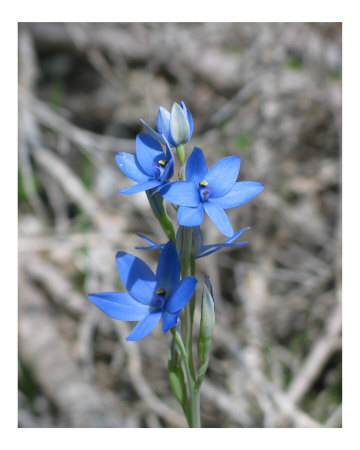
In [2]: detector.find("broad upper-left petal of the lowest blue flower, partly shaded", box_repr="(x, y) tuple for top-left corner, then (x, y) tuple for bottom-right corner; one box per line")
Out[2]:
(116, 252), (156, 305)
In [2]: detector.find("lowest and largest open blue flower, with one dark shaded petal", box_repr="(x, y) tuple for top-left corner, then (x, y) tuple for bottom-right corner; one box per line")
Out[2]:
(88, 241), (197, 341)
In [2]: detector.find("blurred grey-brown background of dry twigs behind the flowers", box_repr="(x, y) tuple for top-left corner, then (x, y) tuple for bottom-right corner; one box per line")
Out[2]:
(18, 23), (342, 428)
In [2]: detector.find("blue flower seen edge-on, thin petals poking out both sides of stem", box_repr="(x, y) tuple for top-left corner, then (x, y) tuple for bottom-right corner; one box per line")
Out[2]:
(135, 226), (250, 258)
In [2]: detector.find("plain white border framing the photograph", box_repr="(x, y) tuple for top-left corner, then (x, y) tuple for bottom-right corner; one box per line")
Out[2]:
(0, 0), (360, 450)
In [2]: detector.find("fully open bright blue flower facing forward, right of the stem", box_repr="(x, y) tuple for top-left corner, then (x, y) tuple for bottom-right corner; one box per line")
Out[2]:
(159, 147), (264, 236)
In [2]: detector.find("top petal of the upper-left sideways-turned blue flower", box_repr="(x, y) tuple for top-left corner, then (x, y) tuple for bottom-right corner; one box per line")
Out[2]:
(136, 133), (165, 178)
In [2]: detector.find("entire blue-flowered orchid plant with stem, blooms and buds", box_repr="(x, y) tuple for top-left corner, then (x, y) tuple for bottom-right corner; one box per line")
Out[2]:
(88, 98), (263, 428)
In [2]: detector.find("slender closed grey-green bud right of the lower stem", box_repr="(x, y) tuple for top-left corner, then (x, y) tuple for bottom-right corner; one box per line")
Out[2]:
(197, 276), (215, 365)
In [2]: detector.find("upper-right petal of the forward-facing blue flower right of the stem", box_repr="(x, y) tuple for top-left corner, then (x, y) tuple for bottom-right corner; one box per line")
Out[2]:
(204, 156), (241, 198)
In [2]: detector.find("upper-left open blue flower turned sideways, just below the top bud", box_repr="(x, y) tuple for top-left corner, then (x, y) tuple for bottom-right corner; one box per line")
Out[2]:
(115, 133), (174, 194)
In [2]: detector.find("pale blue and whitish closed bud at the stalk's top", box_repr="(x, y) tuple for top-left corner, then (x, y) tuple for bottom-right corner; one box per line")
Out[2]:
(140, 102), (194, 147)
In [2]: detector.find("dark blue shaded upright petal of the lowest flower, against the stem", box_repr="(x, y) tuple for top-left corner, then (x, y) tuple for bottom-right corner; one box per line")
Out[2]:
(156, 241), (180, 294)
